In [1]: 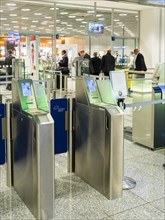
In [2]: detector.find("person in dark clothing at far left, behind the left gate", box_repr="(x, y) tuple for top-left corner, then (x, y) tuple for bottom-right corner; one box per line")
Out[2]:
(5, 50), (15, 90)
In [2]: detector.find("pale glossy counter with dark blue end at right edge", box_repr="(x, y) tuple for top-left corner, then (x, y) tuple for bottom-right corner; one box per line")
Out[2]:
(132, 82), (165, 149)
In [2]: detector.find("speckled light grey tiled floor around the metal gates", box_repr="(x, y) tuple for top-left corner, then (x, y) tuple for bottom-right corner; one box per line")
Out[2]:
(0, 140), (165, 220)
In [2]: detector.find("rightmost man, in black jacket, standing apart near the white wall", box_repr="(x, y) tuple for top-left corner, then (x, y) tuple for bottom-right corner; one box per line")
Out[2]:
(134, 49), (147, 78)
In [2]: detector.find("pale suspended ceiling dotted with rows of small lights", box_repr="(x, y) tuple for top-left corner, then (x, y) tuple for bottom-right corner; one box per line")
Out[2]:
(0, 0), (164, 37)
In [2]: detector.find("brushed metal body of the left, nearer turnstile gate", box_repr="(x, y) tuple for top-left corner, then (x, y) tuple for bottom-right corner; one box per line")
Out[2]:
(12, 80), (54, 219)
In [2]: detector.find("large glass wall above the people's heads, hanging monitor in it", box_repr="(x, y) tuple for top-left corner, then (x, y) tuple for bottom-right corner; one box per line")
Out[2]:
(0, 0), (139, 75)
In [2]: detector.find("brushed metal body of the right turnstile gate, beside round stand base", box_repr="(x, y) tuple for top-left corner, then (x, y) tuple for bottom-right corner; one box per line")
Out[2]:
(75, 77), (123, 199)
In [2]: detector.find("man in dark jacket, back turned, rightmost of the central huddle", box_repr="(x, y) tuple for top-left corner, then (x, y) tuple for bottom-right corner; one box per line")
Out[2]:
(101, 50), (115, 76)
